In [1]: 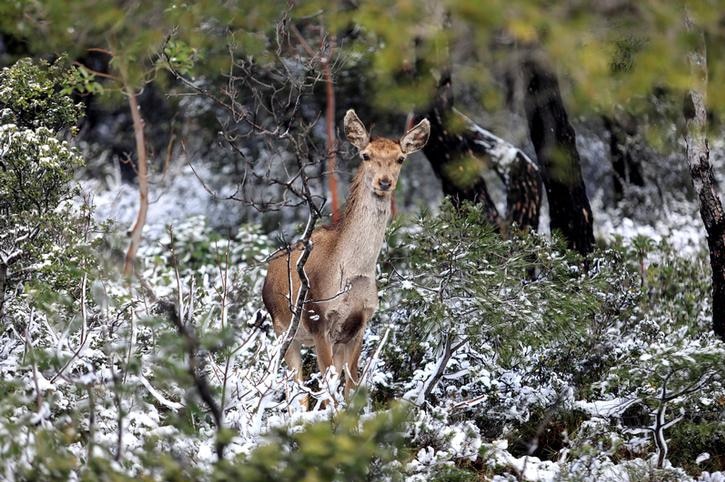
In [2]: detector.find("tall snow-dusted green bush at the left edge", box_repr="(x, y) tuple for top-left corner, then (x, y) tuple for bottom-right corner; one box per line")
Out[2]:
(0, 59), (87, 315)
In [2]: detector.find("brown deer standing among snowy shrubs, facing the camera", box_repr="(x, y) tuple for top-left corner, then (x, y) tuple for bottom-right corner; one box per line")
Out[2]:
(262, 109), (430, 404)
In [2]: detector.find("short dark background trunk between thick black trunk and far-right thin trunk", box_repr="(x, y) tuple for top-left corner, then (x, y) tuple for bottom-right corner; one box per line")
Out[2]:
(602, 116), (644, 202)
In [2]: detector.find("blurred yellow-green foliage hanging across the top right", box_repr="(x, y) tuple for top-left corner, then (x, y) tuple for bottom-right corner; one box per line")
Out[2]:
(316, 0), (725, 123)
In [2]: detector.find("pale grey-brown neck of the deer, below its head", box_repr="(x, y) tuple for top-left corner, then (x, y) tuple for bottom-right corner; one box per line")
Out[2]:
(334, 169), (390, 278)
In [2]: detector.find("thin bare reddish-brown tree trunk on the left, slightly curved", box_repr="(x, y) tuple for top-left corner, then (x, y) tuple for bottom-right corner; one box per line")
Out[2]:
(123, 89), (149, 276)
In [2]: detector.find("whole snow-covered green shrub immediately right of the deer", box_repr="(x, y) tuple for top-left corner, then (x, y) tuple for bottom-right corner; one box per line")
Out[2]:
(383, 201), (636, 412)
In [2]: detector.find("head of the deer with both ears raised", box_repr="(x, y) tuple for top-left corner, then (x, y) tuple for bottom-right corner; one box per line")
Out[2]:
(344, 109), (430, 199)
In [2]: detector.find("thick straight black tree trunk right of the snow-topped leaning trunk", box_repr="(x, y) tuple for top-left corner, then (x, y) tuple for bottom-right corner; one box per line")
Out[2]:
(523, 59), (594, 255)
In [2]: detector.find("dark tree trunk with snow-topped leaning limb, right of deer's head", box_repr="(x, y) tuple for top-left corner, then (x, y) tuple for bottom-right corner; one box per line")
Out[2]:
(416, 72), (541, 231)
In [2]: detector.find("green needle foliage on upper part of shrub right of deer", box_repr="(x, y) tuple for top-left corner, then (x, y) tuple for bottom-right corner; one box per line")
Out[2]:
(382, 201), (636, 365)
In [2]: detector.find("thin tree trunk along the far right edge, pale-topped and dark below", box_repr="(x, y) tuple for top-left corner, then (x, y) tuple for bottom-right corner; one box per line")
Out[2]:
(683, 13), (725, 340)
